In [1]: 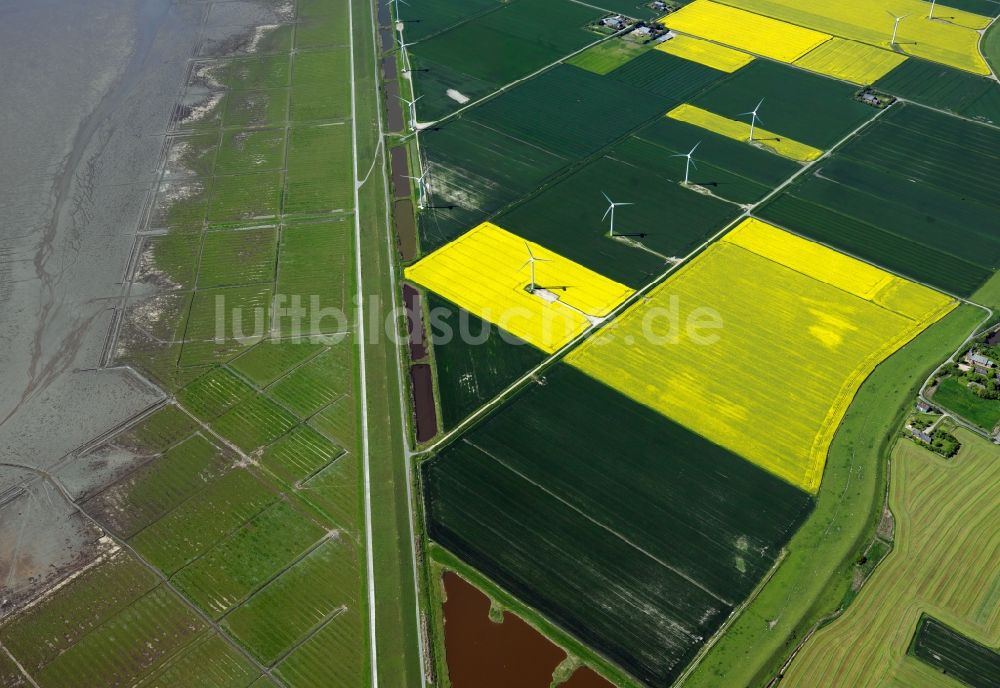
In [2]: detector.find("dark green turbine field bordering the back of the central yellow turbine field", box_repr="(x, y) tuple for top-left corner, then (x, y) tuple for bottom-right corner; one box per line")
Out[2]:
(497, 143), (744, 288)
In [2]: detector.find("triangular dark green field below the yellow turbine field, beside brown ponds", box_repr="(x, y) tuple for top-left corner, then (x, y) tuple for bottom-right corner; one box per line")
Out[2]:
(426, 292), (545, 430)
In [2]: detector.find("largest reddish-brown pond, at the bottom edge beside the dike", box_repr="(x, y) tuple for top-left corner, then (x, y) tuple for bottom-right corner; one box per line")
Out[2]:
(444, 571), (579, 688)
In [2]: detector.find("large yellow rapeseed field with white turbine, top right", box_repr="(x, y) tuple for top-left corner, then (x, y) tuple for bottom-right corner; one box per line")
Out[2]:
(712, 0), (990, 75)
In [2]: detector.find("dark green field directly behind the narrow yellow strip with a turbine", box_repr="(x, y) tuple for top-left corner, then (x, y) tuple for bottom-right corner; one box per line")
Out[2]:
(688, 60), (875, 149)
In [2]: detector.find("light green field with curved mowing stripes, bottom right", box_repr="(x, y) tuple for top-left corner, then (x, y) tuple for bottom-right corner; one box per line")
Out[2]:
(782, 430), (1000, 688)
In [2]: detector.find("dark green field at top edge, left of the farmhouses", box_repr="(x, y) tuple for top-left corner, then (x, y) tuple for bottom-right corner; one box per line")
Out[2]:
(404, 0), (601, 85)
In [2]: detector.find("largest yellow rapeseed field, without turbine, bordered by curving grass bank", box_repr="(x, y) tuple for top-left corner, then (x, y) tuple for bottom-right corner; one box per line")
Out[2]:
(567, 220), (955, 493)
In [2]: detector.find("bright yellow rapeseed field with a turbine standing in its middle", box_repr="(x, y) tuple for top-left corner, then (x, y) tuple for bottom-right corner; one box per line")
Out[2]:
(405, 222), (633, 353)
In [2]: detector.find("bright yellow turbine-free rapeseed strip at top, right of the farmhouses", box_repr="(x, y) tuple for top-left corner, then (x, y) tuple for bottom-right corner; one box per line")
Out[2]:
(660, 0), (830, 62)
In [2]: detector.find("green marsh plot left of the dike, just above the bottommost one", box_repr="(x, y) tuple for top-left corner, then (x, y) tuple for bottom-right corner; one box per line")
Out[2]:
(222, 536), (361, 666)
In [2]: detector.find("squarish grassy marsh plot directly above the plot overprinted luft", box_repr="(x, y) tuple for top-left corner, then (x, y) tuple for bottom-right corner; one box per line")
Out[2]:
(198, 227), (278, 289)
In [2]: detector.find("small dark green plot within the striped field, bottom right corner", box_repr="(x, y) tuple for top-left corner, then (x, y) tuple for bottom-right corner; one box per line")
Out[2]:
(910, 616), (1000, 688)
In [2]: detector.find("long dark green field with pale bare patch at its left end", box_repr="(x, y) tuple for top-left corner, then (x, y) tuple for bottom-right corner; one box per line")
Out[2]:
(420, 55), (720, 253)
